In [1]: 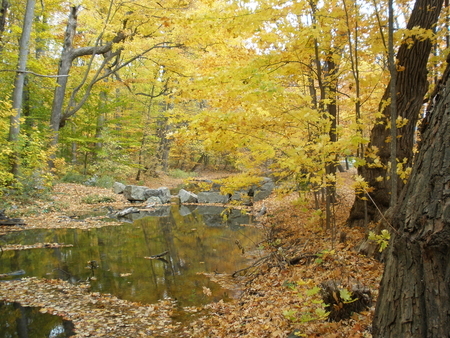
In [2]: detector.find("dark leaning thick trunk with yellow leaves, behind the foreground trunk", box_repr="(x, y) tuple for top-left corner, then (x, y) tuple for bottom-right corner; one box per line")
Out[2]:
(348, 0), (444, 226)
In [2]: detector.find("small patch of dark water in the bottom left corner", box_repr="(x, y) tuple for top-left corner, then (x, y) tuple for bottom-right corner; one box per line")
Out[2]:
(0, 302), (74, 338)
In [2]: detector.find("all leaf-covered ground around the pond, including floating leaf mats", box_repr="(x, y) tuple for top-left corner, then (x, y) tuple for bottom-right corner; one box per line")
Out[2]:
(0, 171), (382, 338)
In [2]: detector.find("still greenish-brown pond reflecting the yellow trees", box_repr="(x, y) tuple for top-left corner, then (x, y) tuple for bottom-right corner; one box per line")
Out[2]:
(0, 205), (261, 338)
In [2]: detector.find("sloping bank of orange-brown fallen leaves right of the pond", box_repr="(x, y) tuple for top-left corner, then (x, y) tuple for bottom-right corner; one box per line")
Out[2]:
(184, 174), (382, 338)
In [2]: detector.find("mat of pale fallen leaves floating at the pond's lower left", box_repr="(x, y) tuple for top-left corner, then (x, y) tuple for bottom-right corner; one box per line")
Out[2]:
(0, 277), (178, 337)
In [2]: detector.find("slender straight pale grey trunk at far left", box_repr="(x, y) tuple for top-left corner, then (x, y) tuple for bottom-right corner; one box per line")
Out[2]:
(8, 0), (35, 178)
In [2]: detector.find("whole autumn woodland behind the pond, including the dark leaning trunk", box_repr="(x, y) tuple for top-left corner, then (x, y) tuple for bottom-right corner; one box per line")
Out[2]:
(0, 0), (449, 336)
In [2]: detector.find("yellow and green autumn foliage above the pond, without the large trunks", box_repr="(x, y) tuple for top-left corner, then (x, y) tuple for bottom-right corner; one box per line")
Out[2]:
(0, 0), (446, 187)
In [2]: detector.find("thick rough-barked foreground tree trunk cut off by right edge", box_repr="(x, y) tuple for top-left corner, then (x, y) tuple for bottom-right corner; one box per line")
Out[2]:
(373, 59), (450, 338)
